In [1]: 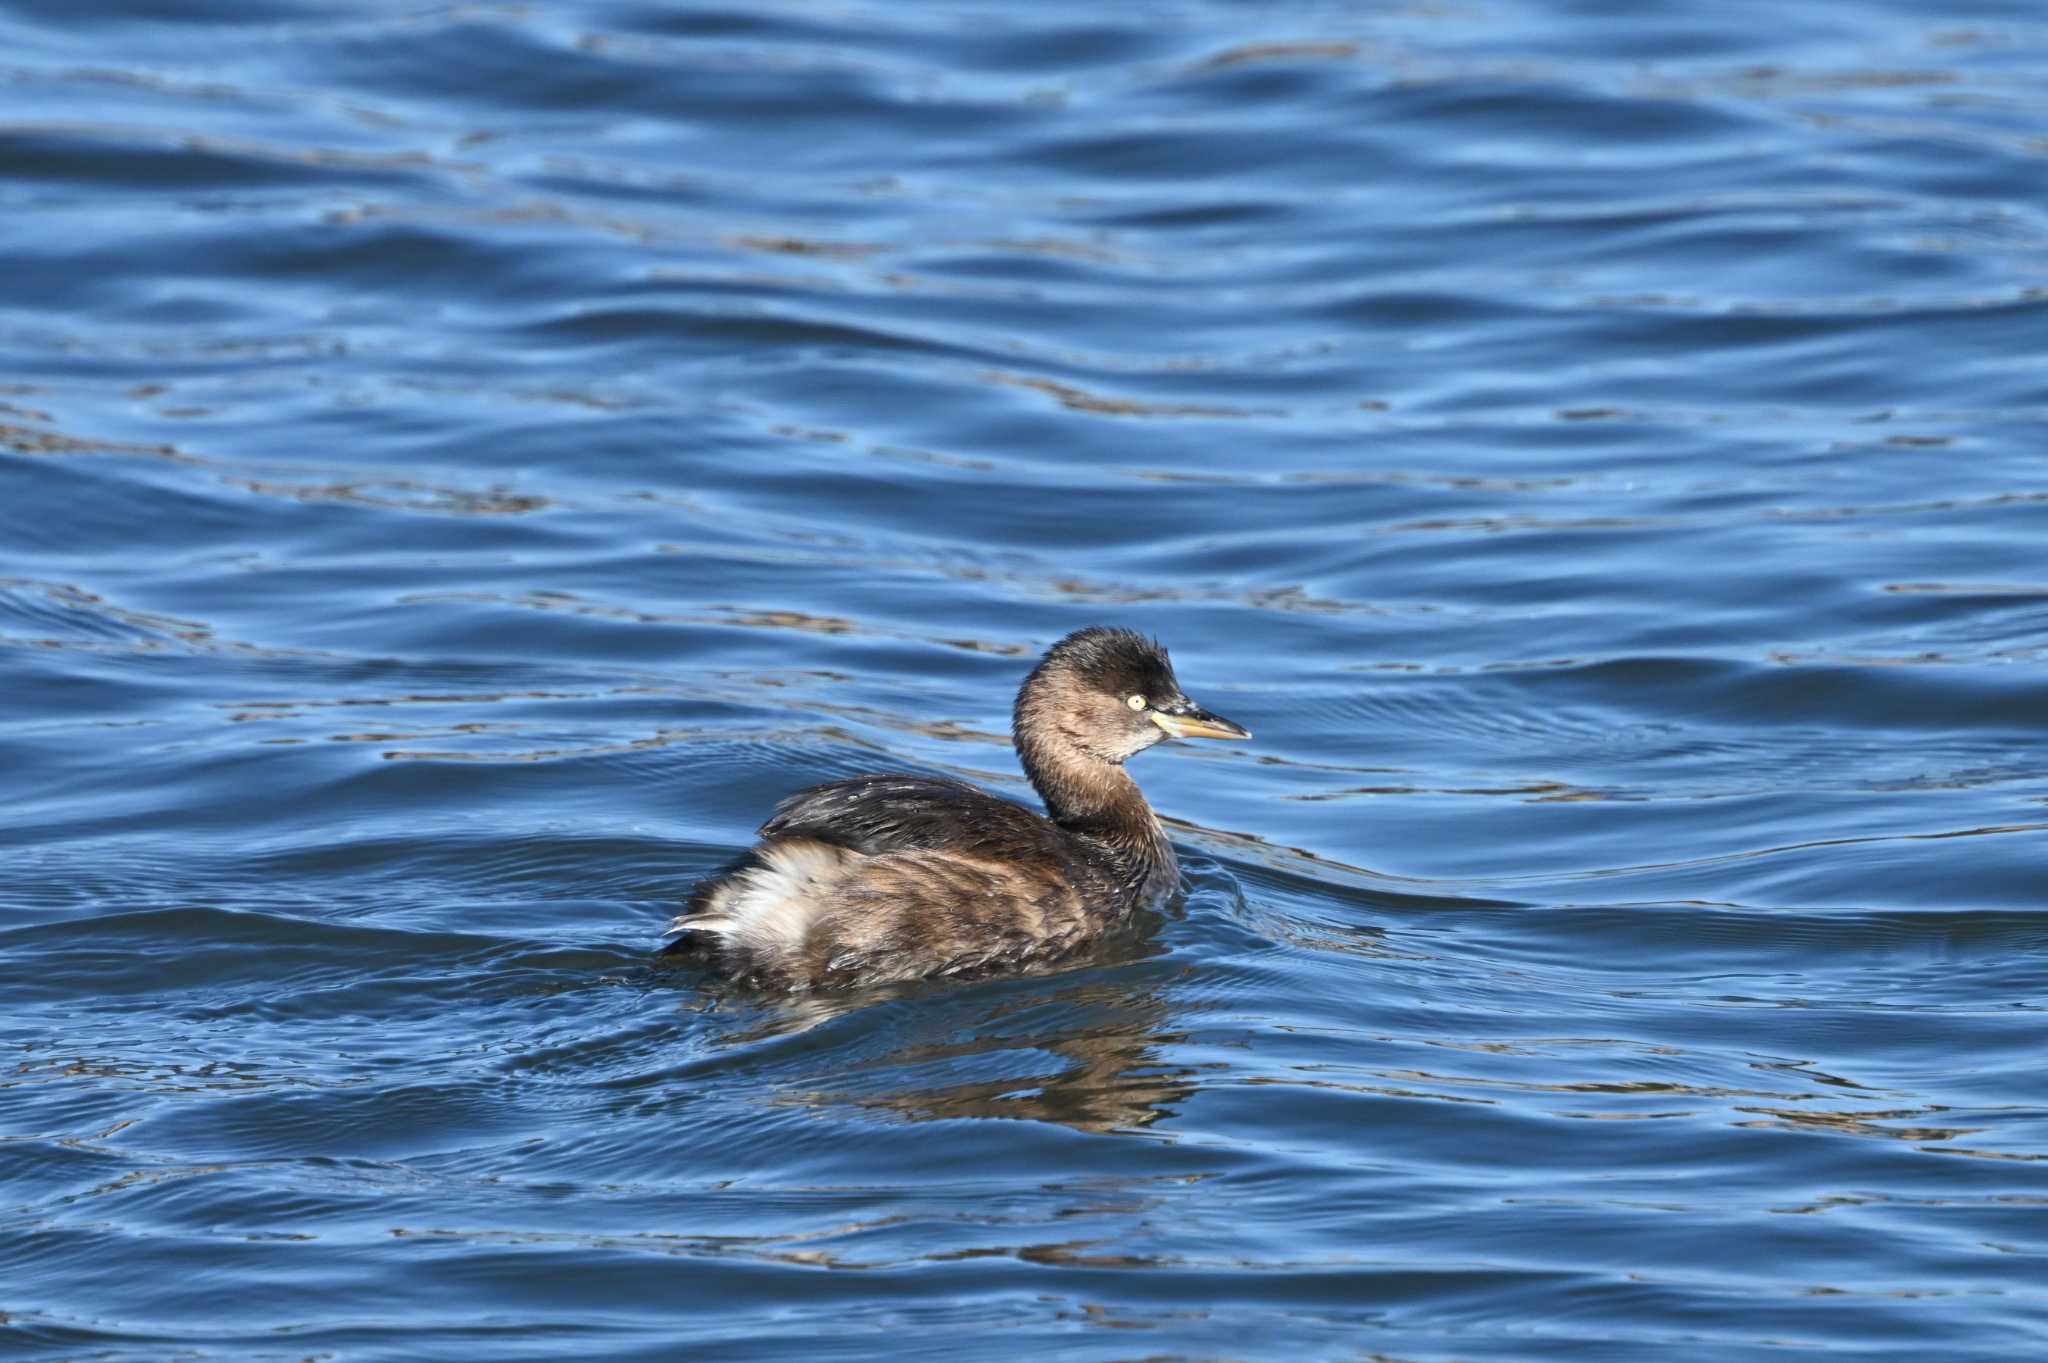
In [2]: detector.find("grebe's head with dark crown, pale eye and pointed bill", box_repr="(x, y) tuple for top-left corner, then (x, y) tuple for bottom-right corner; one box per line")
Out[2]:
(1016, 626), (1251, 763)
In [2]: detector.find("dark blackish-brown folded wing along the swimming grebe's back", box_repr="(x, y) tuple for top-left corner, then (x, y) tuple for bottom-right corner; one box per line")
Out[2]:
(760, 776), (1069, 866)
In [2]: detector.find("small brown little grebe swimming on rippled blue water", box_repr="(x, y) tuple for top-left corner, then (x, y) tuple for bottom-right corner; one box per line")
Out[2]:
(668, 626), (1251, 991)
